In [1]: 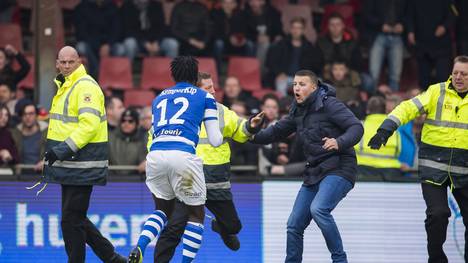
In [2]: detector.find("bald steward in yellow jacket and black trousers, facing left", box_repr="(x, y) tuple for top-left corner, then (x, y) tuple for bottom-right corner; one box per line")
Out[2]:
(44, 46), (126, 263)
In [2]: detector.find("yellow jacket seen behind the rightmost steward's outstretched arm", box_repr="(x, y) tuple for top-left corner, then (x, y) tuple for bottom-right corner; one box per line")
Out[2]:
(354, 114), (401, 169)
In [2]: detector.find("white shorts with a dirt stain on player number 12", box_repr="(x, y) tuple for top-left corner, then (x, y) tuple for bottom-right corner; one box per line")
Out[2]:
(146, 150), (206, 206)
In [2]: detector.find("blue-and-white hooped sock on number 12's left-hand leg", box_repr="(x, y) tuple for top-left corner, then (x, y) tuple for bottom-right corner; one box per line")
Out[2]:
(137, 210), (167, 254)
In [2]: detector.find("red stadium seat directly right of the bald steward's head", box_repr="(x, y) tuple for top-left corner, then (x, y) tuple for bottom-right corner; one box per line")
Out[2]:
(99, 57), (133, 89)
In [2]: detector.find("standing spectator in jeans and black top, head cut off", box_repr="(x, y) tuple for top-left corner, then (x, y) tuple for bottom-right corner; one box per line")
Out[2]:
(364, 0), (409, 91)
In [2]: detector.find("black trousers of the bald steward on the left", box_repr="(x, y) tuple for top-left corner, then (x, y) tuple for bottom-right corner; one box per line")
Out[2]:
(61, 185), (114, 263)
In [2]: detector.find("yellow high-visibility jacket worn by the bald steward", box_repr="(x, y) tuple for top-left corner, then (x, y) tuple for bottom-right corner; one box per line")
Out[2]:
(44, 65), (108, 185)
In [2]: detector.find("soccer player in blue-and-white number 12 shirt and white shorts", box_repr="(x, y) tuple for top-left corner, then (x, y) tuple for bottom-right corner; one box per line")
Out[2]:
(129, 56), (223, 263)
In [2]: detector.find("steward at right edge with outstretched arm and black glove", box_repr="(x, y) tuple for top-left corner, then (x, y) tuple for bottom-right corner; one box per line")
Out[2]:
(369, 56), (468, 263)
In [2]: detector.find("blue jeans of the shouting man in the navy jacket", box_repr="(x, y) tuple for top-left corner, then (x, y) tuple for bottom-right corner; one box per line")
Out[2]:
(285, 175), (353, 263)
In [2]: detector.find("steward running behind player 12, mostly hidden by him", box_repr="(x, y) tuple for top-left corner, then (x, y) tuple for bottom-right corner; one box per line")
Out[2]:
(154, 72), (260, 263)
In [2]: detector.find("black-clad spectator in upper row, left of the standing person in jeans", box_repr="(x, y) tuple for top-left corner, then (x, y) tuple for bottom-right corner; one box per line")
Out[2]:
(317, 13), (362, 72)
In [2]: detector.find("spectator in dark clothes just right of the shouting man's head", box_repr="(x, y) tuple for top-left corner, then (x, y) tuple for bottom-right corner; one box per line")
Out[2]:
(323, 60), (365, 119)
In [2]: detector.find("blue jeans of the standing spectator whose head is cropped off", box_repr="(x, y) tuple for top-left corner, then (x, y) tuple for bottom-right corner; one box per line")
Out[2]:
(369, 33), (404, 91)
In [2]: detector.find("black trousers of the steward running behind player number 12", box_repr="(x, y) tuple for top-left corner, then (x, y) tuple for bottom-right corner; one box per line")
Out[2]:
(154, 200), (242, 263)
